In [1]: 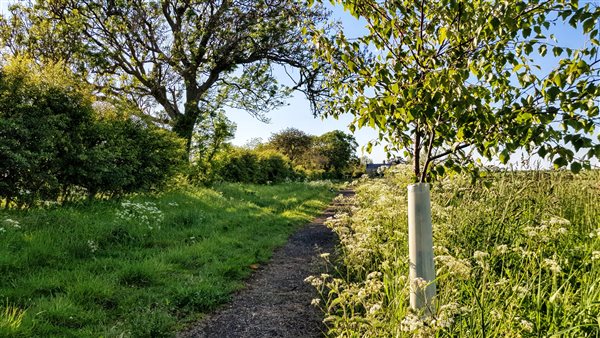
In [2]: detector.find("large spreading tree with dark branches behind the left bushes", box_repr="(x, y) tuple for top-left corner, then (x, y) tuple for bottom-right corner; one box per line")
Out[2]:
(3, 0), (325, 152)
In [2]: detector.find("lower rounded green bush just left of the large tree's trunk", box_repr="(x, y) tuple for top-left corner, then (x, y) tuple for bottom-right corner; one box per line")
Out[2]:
(75, 119), (184, 196)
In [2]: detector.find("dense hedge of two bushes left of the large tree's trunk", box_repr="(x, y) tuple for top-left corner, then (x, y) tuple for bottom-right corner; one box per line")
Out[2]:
(0, 59), (184, 207)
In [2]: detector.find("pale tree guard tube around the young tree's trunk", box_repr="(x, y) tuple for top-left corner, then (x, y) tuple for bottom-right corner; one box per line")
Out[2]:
(408, 183), (436, 314)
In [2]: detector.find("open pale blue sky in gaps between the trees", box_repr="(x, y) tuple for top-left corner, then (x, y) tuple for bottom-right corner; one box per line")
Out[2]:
(0, 0), (585, 166)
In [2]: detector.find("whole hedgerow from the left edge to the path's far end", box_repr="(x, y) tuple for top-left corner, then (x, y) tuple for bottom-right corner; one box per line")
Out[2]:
(0, 57), (364, 208)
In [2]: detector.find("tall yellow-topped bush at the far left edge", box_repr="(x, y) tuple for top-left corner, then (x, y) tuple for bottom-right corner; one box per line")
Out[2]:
(0, 60), (93, 205)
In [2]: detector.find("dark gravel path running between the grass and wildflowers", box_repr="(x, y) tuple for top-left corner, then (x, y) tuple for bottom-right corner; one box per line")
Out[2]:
(178, 191), (352, 338)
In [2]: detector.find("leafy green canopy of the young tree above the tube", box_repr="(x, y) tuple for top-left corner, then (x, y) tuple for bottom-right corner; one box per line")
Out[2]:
(315, 0), (600, 182)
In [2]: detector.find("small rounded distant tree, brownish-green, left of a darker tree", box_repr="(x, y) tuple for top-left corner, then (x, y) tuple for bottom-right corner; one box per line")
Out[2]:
(268, 128), (314, 164)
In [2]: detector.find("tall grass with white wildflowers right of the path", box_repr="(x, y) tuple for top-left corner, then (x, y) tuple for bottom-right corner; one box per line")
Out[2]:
(309, 167), (600, 337)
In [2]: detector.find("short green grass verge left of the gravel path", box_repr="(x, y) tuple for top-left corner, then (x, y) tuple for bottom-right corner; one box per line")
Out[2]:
(0, 183), (333, 337)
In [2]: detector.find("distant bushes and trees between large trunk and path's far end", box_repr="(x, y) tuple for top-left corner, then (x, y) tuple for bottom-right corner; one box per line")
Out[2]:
(194, 128), (364, 184)
